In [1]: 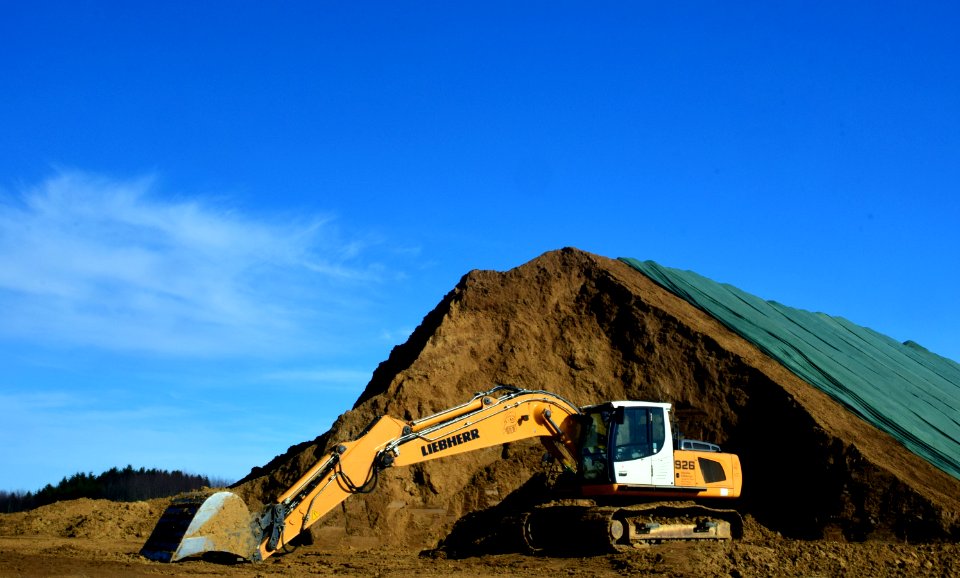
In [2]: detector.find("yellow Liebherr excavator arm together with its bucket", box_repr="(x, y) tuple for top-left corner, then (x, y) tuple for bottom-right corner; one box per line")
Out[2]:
(141, 385), (580, 562)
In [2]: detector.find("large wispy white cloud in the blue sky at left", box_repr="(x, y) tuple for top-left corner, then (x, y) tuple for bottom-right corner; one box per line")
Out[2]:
(0, 173), (383, 356)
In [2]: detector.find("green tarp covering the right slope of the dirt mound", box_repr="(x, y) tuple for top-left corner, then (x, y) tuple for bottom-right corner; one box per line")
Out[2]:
(621, 258), (960, 479)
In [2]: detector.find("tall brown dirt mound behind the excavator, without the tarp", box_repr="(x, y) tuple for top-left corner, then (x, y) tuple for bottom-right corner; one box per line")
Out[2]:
(235, 249), (960, 548)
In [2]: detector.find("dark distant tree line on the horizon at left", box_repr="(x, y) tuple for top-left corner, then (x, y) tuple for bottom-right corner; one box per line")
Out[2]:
(0, 465), (229, 513)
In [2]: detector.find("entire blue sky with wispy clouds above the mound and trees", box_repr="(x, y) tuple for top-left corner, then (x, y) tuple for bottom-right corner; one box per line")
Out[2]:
(0, 0), (960, 490)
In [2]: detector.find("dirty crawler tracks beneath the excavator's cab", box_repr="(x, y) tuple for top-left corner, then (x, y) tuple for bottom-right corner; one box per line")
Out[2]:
(517, 500), (743, 555)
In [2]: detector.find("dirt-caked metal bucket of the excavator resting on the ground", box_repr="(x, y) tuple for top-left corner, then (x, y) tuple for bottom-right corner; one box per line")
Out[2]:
(140, 492), (260, 562)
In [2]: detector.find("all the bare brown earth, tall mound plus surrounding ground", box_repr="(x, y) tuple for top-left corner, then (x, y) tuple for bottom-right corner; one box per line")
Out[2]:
(0, 249), (960, 577)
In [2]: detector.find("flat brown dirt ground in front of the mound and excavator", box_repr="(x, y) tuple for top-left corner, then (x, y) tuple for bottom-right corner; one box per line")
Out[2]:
(0, 500), (960, 578)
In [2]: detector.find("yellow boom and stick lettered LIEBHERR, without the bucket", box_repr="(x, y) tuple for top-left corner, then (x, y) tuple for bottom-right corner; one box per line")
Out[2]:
(254, 385), (580, 560)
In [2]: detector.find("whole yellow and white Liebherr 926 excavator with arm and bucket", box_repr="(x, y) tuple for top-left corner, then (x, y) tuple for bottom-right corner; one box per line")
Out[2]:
(140, 385), (743, 562)
